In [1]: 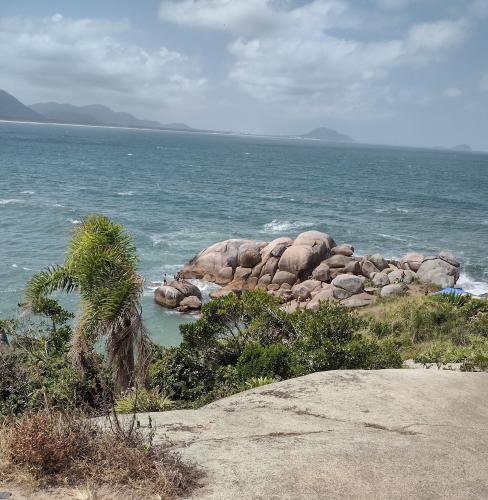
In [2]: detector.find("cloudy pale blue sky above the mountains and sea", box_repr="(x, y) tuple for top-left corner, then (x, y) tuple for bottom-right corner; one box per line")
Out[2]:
(0, 0), (488, 150)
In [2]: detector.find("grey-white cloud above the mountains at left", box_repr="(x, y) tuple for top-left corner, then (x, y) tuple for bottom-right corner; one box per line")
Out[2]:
(0, 14), (206, 111)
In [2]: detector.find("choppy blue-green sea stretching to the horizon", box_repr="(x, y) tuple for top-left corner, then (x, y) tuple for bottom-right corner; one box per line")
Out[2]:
(0, 123), (488, 344)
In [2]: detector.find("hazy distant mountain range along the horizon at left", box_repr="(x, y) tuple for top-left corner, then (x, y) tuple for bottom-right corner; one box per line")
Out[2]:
(0, 90), (193, 130)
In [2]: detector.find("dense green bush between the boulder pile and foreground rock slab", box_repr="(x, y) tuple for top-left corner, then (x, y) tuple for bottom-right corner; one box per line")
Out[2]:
(150, 292), (402, 405)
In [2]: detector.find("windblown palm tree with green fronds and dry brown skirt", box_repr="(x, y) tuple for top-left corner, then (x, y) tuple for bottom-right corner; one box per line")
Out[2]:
(26, 215), (148, 390)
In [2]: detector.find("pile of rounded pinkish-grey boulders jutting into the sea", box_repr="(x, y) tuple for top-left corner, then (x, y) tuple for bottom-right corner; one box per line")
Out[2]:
(154, 231), (460, 312)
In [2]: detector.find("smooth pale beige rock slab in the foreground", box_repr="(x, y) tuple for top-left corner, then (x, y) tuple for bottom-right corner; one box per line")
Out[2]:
(144, 369), (488, 499)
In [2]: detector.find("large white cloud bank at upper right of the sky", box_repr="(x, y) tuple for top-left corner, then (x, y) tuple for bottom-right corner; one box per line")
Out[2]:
(160, 0), (468, 115)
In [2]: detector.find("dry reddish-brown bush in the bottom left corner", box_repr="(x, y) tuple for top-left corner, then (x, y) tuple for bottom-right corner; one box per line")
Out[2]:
(0, 412), (200, 498)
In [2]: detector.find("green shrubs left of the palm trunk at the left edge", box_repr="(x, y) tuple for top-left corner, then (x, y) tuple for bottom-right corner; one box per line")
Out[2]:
(0, 299), (111, 420)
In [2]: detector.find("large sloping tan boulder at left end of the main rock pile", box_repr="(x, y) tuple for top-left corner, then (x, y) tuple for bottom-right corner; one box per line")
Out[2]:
(181, 239), (256, 278)
